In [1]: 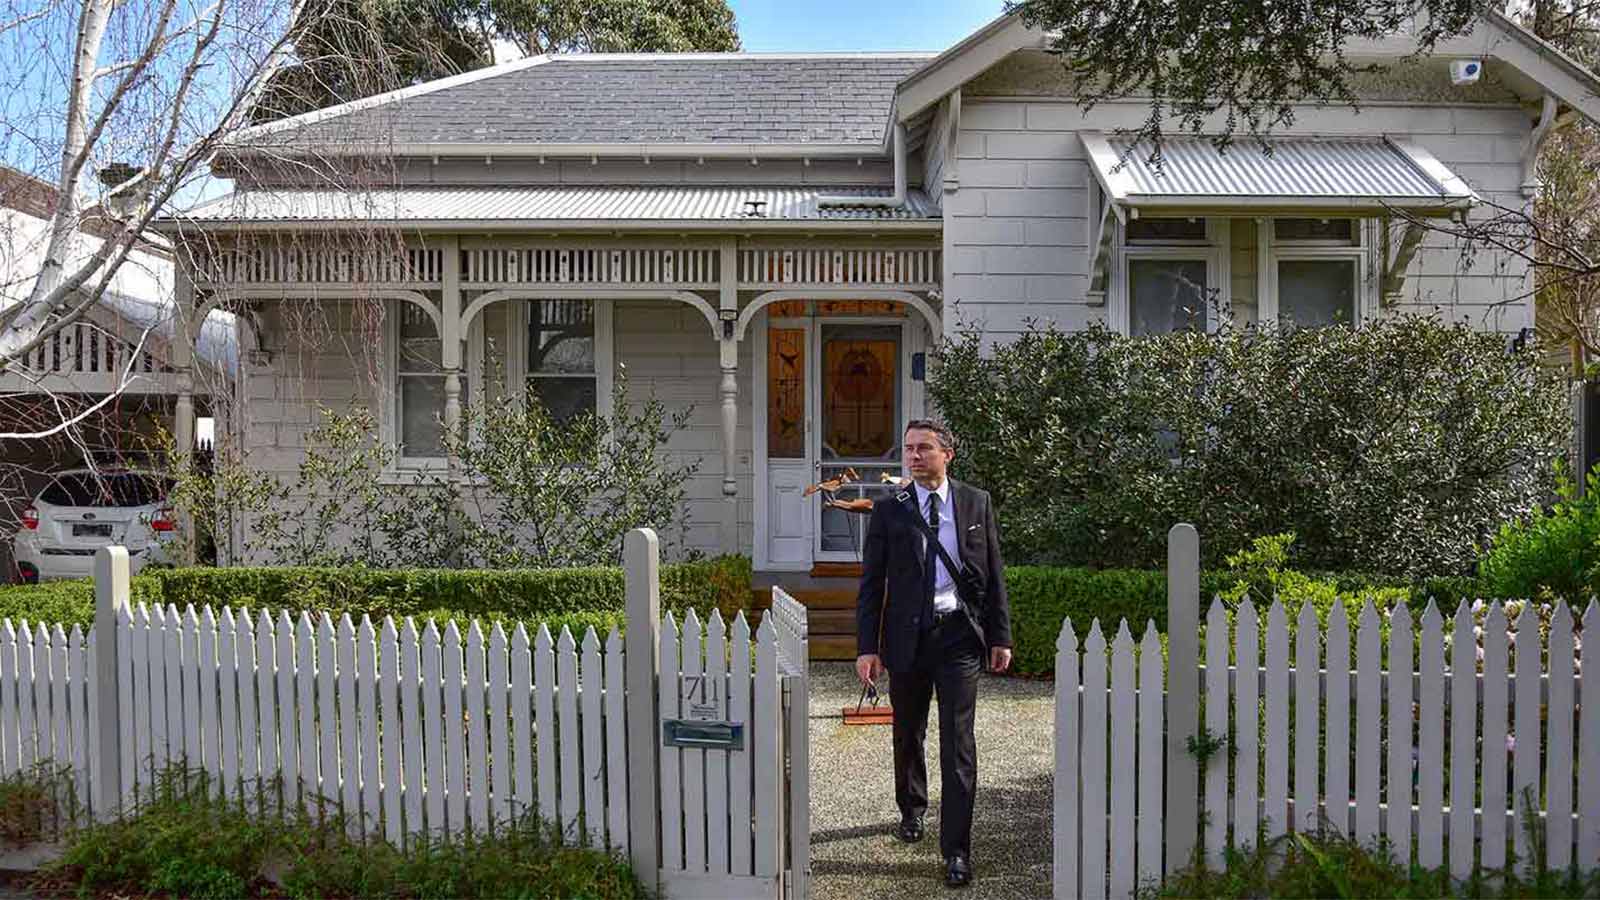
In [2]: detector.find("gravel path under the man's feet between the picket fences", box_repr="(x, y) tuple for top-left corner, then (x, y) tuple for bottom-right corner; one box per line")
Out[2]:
(811, 663), (1054, 900)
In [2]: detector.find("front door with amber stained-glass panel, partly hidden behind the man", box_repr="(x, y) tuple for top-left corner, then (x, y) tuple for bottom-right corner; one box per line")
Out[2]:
(811, 320), (906, 562)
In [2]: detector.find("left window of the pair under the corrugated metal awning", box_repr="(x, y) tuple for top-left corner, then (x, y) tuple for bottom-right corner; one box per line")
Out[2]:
(1114, 218), (1227, 336)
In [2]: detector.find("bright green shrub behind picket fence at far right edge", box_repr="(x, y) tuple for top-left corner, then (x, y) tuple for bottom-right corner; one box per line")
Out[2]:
(1478, 468), (1600, 602)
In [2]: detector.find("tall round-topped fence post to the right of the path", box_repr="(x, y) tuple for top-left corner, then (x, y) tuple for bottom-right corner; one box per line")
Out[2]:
(1163, 522), (1200, 873)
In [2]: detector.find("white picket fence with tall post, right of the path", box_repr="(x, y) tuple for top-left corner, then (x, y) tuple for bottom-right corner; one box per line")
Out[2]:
(1054, 525), (1600, 898)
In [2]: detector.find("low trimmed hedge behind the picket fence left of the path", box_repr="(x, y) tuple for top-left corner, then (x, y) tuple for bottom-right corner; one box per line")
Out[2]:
(0, 557), (750, 634)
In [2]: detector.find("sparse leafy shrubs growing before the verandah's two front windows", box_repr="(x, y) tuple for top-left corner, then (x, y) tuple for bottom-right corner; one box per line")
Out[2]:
(170, 373), (701, 569)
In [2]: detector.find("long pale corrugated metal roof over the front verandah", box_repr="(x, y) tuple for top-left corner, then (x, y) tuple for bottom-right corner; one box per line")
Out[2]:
(163, 186), (938, 229)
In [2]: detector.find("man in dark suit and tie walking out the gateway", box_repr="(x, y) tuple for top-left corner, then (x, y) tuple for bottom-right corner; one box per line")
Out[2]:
(856, 420), (1011, 887)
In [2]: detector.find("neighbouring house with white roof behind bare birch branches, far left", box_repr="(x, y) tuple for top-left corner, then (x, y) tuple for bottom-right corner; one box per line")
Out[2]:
(0, 167), (238, 578)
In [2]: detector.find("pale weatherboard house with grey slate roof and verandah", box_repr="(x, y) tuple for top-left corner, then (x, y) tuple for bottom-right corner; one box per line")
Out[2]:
(162, 8), (1600, 614)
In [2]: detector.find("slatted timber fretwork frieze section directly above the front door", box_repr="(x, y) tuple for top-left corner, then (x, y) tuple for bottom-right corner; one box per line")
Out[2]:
(739, 248), (939, 290)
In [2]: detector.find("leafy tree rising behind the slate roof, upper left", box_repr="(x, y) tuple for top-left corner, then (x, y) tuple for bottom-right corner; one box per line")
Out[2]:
(254, 0), (739, 122)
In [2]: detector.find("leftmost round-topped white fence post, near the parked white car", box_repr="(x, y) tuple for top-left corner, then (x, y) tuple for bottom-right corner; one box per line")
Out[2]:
(86, 546), (131, 822)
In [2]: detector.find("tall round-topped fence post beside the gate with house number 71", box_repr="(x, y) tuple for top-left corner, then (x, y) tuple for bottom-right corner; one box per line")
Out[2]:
(622, 528), (661, 892)
